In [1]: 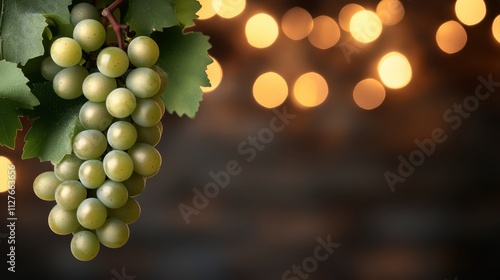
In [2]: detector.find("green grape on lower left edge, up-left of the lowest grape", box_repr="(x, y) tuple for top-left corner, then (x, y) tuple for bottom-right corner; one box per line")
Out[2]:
(47, 204), (80, 235)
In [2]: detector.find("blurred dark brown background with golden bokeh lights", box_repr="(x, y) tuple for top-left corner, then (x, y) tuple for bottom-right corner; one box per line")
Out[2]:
(0, 0), (500, 280)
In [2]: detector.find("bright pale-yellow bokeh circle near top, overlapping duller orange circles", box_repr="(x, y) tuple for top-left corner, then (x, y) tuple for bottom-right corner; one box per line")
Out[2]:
(349, 10), (382, 43)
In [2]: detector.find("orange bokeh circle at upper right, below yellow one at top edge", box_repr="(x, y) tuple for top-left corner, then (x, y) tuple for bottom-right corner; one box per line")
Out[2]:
(436, 20), (467, 54)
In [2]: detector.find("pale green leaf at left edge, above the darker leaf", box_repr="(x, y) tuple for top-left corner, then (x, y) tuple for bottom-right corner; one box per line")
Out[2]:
(0, 60), (39, 109)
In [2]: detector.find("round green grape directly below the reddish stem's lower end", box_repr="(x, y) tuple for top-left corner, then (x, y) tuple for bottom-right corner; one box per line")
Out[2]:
(96, 47), (129, 78)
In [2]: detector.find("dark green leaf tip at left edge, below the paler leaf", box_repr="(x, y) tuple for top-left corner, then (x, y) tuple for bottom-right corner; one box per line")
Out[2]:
(0, 99), (23, 149)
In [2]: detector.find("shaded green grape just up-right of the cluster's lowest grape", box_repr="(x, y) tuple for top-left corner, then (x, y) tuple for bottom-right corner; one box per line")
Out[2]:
(95, 217), (130, 249)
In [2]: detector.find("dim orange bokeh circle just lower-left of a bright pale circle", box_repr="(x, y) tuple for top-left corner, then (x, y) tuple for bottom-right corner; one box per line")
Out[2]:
(352, 78), (385, 110)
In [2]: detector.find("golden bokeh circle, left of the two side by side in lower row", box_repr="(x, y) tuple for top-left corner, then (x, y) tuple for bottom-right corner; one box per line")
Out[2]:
(253, 72), (288, 108)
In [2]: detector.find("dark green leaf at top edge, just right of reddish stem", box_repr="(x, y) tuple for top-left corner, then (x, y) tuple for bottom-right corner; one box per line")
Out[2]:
(125, 0), (179, 36)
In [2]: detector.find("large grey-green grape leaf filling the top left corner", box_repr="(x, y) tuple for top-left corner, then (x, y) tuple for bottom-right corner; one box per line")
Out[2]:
(1, 0), (71, 65)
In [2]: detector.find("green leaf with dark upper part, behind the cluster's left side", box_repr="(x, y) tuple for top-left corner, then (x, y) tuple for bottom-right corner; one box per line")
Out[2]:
(22, 82), (86, 163)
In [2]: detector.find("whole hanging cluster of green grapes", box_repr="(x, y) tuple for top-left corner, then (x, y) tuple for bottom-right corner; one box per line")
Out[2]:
(33, 4), (168, 261)
